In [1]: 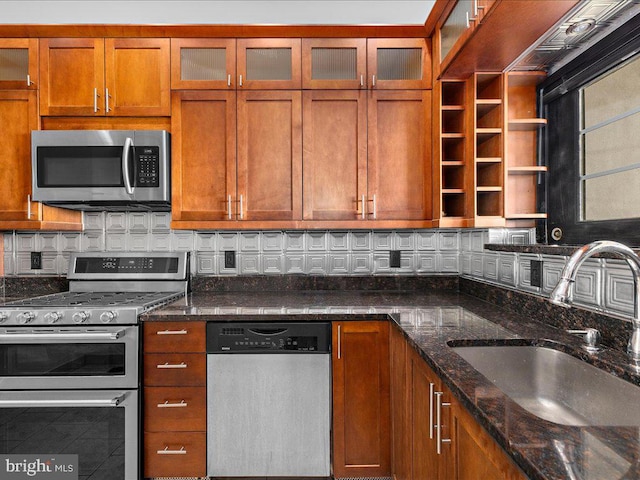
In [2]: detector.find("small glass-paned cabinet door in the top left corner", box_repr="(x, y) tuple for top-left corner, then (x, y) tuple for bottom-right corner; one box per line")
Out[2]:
(0, 38), (39, 90)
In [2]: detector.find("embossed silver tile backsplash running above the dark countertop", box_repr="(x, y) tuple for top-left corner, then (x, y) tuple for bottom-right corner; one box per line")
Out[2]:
(2, 212), (634, 316)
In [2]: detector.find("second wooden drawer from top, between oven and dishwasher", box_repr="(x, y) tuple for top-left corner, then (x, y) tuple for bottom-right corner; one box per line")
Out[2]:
(143, 353), (207, 387)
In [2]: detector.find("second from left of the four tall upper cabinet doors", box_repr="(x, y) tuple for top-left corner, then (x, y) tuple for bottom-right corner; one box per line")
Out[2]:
(237, 91), (302, 220)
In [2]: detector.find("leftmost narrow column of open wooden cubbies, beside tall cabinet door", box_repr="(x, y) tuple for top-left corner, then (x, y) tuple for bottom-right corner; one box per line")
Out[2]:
(439, 80), (472, 227)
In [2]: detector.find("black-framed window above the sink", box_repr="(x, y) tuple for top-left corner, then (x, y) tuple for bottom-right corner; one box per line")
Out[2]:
(538, 18), (640, 246)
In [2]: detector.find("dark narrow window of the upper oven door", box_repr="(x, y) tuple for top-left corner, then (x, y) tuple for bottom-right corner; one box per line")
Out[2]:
(0, 343), (125, 377)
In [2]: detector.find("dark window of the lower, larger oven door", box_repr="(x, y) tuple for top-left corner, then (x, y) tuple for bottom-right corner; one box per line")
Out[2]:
(0, 407), (125, 480)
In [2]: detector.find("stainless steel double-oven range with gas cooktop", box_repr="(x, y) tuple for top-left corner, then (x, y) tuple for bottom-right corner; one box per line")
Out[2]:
(0, 252), (189, 480)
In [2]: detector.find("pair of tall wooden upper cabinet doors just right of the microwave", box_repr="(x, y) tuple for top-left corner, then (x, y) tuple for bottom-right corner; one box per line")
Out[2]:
(172, 90), (302, 228)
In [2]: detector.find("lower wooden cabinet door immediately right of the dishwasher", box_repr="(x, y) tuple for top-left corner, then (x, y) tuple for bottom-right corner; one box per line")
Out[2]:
(332, 322), (391, 477)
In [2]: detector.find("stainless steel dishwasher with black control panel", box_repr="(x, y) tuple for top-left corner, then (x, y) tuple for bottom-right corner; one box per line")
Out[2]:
(207, 322), (331, 477)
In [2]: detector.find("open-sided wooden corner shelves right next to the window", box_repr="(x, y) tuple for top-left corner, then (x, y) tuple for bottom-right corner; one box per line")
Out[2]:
(504, 72), (547, 227)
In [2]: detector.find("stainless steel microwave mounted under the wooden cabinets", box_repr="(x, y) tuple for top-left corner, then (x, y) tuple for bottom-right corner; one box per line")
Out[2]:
(31, 130), (171, 211)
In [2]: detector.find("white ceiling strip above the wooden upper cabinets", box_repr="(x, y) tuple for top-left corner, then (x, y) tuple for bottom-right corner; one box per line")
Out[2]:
(0, 0), (435, 25)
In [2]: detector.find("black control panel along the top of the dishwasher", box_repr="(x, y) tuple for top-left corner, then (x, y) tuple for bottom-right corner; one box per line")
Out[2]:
(207, 322), (331, 353)
